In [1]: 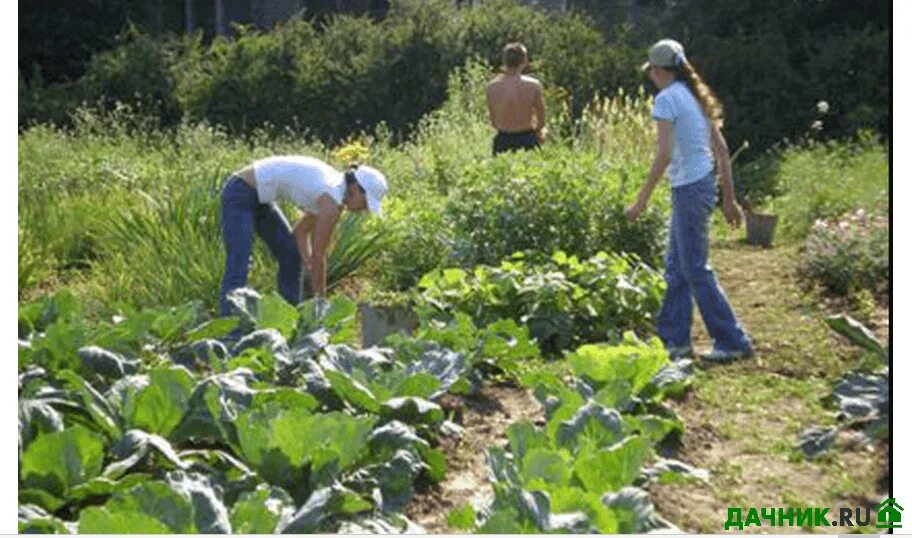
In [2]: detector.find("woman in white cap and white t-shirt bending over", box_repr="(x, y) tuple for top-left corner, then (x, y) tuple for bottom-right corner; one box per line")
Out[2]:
(219, 155), (388, 316)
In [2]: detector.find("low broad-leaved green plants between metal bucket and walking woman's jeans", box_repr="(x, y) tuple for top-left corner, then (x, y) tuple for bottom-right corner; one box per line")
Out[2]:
(418, 252), (664, 354)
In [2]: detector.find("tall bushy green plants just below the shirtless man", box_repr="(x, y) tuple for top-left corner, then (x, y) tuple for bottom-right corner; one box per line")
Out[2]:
(445, 146), (665, 266)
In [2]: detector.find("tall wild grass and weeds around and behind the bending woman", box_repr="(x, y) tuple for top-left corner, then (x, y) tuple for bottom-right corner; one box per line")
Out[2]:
(18, 59), (661, 315)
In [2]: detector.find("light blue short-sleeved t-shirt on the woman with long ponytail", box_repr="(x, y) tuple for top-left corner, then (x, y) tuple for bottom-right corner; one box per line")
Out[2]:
(652, 80), (714, 187)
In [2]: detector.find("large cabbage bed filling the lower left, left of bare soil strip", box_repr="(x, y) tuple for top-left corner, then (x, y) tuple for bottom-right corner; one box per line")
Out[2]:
(19, 289), (538, 534)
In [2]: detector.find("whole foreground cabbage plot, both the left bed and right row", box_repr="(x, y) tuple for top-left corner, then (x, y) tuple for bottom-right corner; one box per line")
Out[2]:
(19, 280), (686, 533)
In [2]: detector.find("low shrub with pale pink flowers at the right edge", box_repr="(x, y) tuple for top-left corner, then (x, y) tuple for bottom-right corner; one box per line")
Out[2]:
(798, 205), (890, 302)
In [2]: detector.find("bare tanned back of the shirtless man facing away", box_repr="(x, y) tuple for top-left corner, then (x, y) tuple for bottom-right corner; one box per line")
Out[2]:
(485, 75), (545, 133)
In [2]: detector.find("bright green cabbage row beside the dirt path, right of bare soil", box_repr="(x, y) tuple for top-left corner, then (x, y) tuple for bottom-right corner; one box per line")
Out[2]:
(464, 335), (681, 533)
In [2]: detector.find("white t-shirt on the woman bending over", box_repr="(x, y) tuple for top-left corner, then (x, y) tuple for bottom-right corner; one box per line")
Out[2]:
(253, 155), (345, 214)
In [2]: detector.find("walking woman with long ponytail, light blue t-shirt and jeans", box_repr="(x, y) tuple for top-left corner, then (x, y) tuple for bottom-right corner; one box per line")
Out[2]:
(626, 39), (753, 362)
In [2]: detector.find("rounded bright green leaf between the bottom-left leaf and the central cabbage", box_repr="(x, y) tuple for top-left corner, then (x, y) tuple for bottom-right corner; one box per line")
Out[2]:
(124, 367), (195, 437)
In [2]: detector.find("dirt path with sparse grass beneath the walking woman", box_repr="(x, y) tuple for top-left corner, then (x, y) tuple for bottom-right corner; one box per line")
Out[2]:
(654, 240), (886, 533)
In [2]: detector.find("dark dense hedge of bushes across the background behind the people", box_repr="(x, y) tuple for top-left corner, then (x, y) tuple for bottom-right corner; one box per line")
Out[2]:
(19, 0), (890, 155)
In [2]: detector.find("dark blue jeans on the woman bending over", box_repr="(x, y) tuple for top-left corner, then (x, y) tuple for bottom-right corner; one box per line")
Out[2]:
(219, 176), (301, 316)
